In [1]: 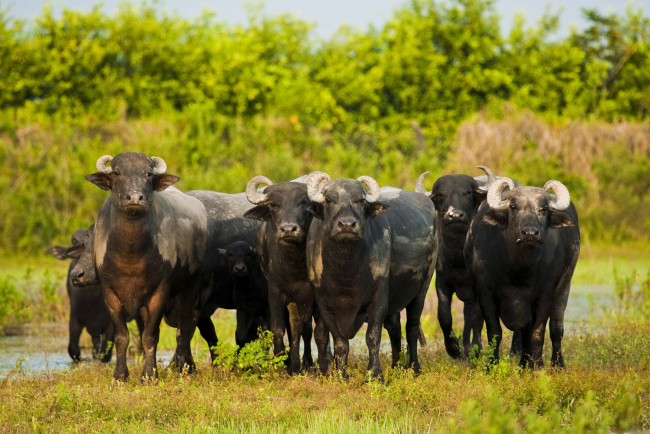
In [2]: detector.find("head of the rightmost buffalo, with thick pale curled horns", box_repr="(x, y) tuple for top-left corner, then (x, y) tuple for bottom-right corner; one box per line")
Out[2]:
(484, 178), (577, 248)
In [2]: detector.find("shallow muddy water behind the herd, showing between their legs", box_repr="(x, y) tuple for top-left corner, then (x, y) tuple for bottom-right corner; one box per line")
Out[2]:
(0, 285), (614, 378)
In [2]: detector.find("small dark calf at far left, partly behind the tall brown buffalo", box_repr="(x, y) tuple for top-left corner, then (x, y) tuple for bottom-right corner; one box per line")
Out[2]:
(48, 226), (115, 363)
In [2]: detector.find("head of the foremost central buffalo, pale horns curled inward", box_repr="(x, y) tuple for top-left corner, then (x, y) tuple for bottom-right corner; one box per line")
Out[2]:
(307, 172), (389, 241)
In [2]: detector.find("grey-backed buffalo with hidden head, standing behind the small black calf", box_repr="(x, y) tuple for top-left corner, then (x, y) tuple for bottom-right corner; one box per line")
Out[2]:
(181, 190), (260, 362)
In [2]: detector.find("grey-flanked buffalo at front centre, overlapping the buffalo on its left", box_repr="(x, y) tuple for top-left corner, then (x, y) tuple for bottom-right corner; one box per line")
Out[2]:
(307, 172), (438, 376)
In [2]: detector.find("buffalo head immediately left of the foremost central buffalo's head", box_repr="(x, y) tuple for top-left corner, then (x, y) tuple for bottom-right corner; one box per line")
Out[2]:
(244, 176), (314, 244)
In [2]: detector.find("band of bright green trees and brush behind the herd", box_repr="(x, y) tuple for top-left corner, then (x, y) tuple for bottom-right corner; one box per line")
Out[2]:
(0, 0), (650, 253)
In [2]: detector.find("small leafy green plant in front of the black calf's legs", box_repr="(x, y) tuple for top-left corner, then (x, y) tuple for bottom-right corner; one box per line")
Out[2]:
(213, 329), (289, 378)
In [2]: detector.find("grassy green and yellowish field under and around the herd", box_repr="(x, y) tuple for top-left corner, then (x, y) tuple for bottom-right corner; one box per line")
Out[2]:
(0, 246), (650, 433)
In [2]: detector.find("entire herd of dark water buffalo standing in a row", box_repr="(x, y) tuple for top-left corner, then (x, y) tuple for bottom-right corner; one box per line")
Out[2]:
(48, 152), (580, 382)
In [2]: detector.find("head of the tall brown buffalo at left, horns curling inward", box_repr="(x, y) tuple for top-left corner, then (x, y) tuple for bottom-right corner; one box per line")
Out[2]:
(86, 152), (179, 218)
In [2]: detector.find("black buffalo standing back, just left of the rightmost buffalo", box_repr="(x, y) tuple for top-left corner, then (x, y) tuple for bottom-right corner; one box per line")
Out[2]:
(415, 172), (487, 359)
